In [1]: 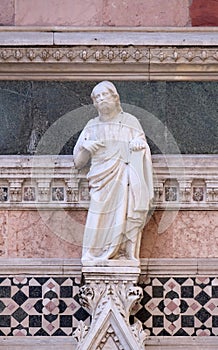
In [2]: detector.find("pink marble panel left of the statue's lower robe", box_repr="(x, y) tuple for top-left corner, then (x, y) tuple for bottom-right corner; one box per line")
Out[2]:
(8, 210), (86, 258)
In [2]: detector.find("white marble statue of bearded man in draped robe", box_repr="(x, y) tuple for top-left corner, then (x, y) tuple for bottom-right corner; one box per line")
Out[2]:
(73, 81), (153, 262)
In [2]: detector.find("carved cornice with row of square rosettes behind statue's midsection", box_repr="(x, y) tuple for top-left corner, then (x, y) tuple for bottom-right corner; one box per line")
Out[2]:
(0, 155), (218, 210)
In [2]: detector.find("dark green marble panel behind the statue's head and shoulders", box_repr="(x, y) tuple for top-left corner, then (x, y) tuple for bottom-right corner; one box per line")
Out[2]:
(0, 81), (218, 154)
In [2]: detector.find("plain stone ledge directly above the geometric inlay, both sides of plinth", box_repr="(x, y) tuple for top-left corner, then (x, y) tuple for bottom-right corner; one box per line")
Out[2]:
(0, 258), (218, 277)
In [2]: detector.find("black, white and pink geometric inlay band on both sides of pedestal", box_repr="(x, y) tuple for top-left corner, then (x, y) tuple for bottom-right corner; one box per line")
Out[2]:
(0, 276), (218, 336)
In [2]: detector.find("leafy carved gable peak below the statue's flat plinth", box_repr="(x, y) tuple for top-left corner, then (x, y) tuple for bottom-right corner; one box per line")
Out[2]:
(73, 280), (147, 350)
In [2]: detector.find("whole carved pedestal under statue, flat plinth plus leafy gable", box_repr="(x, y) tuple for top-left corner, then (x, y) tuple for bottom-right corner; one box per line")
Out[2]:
(74, 260), (146, 350)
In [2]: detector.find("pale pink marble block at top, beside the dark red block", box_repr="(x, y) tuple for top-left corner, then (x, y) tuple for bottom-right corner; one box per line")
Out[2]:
(103, 0), (190, 27)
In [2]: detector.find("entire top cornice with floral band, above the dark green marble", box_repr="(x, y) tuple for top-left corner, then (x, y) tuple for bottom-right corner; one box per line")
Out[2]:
(0, 28), (218, 80)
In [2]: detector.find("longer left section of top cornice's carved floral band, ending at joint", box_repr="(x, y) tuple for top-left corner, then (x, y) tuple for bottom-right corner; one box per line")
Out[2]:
(0, 46), (149, 63)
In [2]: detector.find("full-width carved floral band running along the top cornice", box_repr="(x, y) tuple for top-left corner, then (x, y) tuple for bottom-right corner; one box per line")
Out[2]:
(0, 46), (218, 64)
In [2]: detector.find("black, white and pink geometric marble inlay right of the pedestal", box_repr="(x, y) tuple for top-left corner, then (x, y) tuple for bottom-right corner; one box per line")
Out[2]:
(131, 276), (218, 336)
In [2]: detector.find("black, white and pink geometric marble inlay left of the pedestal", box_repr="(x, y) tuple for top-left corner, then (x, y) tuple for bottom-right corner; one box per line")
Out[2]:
(0, 276), (90, 336)
